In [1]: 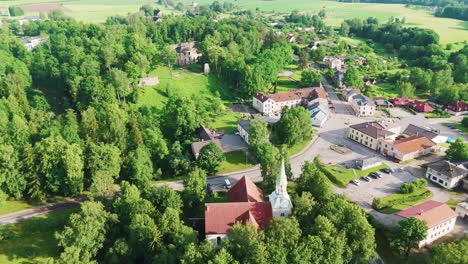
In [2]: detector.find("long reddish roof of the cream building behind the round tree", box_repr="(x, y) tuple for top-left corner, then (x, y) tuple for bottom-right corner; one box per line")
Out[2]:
(255, 87), (327, 103)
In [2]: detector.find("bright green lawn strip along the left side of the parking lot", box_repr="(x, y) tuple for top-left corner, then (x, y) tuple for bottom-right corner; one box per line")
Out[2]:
(322, 164), (388, 187)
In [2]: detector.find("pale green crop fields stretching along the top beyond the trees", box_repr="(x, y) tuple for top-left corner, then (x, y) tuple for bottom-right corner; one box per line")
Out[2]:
(0, 0), (468, 44)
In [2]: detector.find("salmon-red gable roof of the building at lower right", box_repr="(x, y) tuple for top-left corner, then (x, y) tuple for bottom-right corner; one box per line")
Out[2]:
(397, 200), (457, 228)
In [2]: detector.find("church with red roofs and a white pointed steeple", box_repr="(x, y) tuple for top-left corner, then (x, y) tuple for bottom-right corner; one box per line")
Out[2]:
(205, 161), (292, 245)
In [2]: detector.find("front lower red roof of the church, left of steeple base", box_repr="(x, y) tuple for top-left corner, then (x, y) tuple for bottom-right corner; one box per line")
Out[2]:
(205, 202), (273, 235)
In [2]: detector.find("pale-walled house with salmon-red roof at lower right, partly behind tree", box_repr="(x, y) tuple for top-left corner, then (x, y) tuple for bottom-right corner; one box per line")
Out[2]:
(396, 200), (457, 248)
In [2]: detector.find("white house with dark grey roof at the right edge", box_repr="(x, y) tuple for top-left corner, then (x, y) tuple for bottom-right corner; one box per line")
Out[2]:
(425, 160), (468, 189)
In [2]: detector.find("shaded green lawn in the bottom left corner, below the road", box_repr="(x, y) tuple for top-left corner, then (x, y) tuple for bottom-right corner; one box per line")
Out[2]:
(0, 208), (78, 263)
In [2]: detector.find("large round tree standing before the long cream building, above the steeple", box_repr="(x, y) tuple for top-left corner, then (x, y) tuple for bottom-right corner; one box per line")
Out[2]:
(274, 107), (312, 146)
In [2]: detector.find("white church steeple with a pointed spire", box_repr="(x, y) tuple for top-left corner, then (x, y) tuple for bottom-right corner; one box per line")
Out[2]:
(270, 159), (292, 217)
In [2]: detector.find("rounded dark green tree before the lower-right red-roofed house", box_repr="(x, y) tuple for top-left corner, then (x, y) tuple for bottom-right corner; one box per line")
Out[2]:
(391, 217), (427, 257)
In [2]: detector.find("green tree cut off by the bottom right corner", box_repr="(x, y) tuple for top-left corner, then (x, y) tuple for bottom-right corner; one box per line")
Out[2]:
(430, 236), (468, 264)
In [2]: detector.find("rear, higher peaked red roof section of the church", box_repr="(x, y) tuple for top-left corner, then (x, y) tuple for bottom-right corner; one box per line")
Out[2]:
(228, 176), (263, 202)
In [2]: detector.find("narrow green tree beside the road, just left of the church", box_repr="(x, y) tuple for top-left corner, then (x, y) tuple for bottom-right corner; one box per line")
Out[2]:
(182, 167), (207, 211)
